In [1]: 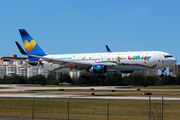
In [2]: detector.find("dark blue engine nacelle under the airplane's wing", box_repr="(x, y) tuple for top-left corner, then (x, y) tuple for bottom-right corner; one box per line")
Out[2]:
(89, 64), (107, 73)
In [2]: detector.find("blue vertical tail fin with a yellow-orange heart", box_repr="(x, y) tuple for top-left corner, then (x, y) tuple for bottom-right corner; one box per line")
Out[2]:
(19, 29), (47, 56)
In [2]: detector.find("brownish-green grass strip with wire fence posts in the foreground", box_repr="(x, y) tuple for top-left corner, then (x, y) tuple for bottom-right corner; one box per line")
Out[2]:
(0, 97), (180, 120)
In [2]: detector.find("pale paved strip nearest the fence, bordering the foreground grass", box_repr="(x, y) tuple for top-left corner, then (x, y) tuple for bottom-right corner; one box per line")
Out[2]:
(0, 93), (180, 101)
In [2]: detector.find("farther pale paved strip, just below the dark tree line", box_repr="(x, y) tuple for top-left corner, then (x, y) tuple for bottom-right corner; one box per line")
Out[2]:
(0, 84), (180, 92)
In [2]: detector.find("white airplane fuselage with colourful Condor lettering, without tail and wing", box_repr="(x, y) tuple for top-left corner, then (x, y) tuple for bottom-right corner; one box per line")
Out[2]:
(31, 51), (177, 71)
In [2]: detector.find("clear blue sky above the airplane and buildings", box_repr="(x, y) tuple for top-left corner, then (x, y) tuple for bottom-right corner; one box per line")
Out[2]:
(0, 0), (180, 63)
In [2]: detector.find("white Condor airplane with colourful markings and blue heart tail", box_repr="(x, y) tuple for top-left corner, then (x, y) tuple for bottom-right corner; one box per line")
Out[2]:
(2, 29), (177, 79)
